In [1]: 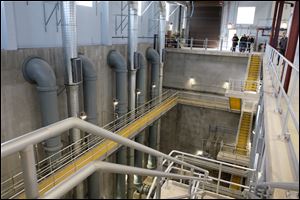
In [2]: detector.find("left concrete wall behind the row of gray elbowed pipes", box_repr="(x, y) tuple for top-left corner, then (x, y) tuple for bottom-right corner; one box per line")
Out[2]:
(1, 43), (152, 198)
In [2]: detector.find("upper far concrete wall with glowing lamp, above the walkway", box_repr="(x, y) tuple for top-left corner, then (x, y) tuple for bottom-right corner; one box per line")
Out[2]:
(163, 49), (248, 95)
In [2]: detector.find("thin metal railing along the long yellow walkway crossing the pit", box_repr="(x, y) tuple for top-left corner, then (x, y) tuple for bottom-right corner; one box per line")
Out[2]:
(1, 87), (266, 198)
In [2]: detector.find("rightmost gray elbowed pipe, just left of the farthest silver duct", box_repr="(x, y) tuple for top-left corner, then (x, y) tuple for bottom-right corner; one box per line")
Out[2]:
(146, 47), (160, 169)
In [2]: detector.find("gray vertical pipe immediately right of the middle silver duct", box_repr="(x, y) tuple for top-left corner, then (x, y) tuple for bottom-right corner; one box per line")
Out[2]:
(134, 52), (147, 188)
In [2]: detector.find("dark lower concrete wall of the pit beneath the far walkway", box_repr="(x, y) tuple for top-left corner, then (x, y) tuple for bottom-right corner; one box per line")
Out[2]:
(160, 104), (240, 158)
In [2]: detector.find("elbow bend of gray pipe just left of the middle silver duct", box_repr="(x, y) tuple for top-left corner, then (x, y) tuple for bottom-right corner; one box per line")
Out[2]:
(107, 50), (127, 72)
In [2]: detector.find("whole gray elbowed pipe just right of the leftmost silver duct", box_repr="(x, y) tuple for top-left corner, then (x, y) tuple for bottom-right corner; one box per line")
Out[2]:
(79, 55), (100, 199)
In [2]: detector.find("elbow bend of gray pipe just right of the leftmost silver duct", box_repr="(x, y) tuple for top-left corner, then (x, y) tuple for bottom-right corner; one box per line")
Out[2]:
(79, 55), (97, 81)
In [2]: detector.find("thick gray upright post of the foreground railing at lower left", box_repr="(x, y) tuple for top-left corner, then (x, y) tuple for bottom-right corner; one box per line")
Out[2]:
(20, 145), (39, 199)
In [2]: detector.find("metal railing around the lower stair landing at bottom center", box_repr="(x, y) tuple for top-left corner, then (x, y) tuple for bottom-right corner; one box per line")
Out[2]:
(147, 150), (256, 199)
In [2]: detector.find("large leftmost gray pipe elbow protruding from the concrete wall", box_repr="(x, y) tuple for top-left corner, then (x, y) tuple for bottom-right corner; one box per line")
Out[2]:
(22, 56), (57, 91)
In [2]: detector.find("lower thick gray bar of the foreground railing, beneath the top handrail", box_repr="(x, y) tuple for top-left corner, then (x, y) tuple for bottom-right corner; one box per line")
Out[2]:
(41, 161), (201, 199)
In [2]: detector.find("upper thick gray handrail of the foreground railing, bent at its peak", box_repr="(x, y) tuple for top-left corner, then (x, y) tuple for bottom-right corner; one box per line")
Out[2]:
(1, 117), (208, 175)
